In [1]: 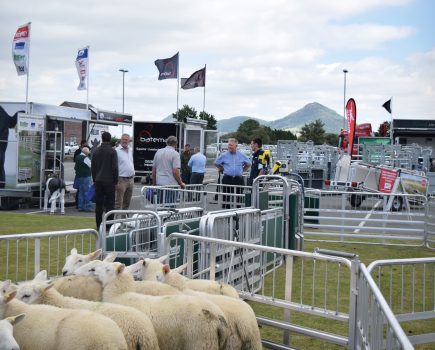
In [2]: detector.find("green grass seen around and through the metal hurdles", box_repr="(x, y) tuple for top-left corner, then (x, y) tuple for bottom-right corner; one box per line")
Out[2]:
(0, 212), (435, 349)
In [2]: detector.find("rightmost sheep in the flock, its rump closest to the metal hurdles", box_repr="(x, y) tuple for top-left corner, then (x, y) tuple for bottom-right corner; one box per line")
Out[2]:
(141, 265), (262, 350)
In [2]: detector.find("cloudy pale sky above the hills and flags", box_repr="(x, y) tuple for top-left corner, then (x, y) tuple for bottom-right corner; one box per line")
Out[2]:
(0, 0), (435, 135)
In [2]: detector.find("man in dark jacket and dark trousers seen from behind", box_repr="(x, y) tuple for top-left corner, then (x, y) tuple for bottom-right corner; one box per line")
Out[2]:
(91, 132), (118, 229)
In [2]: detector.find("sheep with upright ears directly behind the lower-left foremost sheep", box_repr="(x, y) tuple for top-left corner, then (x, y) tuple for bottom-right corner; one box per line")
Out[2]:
(16, 270), (159, 350)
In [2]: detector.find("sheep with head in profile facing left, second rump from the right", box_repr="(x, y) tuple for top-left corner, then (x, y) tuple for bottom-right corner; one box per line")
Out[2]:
(76, 261), (228, 350)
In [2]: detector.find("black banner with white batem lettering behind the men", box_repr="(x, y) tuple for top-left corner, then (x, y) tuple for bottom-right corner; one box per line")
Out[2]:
(133, 122), (177, 173)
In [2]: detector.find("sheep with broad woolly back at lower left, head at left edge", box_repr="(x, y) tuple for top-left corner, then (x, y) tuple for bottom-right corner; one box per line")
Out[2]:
(0, 281), (127, 350)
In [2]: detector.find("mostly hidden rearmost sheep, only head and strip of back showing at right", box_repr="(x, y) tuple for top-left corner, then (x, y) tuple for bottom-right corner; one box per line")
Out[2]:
(139, 256), (239, 299)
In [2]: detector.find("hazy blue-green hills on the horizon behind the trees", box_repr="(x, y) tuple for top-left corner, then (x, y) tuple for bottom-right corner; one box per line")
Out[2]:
(217, 102), (343, 134)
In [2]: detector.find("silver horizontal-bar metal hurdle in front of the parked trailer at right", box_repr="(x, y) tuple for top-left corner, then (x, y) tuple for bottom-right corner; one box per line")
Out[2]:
(304, 190), (429, 246)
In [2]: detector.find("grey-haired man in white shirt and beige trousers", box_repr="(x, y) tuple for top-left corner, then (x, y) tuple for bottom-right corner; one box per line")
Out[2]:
(115, 134), (134, 210)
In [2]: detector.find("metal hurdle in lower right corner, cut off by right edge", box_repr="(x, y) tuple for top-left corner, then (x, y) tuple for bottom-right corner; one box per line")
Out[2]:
(367, 257), (435, 348)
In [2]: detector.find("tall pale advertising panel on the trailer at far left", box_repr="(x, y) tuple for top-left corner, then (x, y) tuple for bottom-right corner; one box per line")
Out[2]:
(16, 113), (44, 187)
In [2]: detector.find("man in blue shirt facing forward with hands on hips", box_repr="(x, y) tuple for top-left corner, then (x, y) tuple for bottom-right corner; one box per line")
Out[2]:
(215, 138), (251, 209)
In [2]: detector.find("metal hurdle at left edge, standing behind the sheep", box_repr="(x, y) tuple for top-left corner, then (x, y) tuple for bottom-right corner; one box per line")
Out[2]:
(0, 229), (102, 282)
